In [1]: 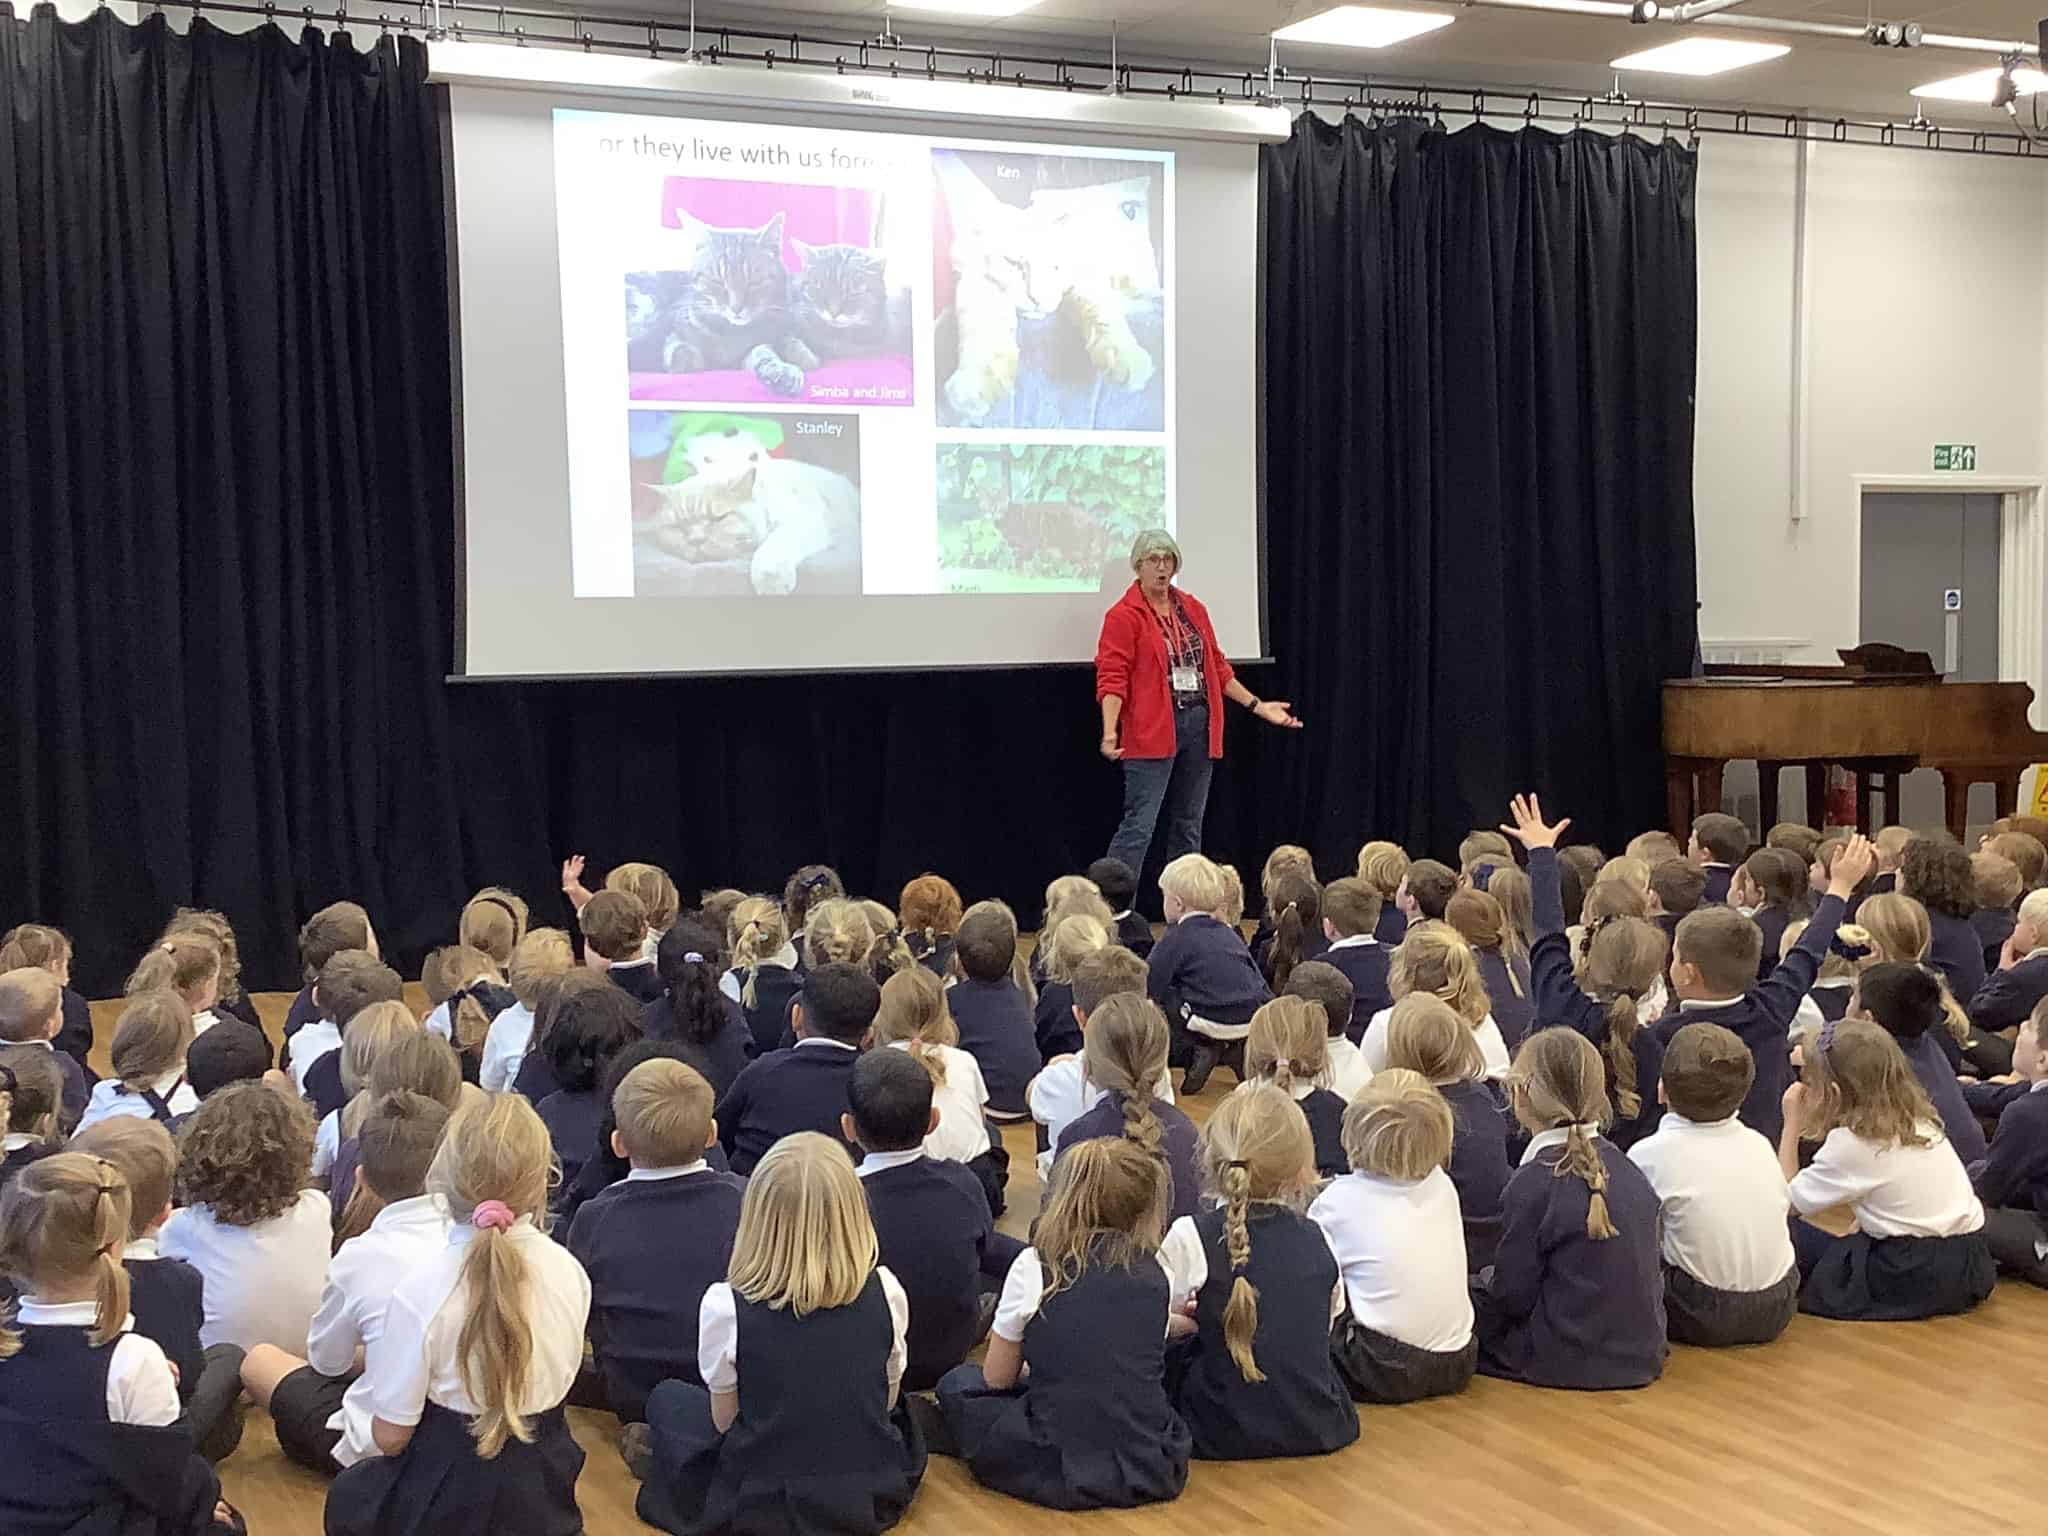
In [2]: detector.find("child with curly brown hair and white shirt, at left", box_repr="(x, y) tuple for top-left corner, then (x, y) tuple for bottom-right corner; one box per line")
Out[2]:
(158, 1083), (332, 1356)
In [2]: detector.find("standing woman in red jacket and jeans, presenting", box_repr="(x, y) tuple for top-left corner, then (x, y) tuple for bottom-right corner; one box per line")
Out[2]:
(1096, 528), (1300, 872)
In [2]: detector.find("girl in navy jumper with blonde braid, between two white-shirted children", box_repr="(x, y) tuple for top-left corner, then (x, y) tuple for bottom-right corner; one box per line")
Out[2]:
(1473, 1028), (1665, 1389)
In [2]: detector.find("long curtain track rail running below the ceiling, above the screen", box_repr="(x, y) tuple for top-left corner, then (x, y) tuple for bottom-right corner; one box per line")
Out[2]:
(136, 0), (2048, 164)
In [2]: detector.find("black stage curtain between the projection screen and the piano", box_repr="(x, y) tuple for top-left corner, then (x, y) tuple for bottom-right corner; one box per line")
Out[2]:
(1239, 115), (1696, 884)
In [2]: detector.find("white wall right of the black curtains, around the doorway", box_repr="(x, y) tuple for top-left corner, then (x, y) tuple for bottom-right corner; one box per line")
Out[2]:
(1694, 137), (2048, 662)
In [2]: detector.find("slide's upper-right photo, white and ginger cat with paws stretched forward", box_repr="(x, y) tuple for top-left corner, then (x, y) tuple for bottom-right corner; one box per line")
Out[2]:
(932, 150), (1165, 430)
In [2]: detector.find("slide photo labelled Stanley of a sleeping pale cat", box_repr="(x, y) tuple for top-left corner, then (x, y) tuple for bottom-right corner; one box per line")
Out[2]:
(627, 410), (860, 598)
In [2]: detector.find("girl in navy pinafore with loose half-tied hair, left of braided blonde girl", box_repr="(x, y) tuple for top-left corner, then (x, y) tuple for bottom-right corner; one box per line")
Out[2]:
(938, 1146), (1192, 1509)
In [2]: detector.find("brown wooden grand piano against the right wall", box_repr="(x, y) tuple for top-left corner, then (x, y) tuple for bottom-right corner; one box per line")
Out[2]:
(1663, 645), (2048, 842)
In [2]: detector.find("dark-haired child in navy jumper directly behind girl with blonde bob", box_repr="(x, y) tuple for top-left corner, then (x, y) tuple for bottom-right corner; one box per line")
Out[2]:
(717, 966), (876, 1174)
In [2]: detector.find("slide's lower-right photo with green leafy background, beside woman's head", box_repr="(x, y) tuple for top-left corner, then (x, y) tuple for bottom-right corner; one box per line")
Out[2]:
(938, 442), (1167, 592)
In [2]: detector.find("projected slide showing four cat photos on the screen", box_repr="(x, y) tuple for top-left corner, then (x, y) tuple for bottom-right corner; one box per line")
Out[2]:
(553, 109), (1176, 600)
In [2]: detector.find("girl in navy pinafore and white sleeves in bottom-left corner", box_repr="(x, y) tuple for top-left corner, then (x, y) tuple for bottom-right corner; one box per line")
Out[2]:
(0, 1153), (242, 1536)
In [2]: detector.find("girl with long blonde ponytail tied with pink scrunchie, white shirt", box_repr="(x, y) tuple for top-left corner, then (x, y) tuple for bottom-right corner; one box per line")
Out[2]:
(326, 1094), (590, 1536)
